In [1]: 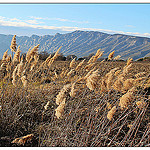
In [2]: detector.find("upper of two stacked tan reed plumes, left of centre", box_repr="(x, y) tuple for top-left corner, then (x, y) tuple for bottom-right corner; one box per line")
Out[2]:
(56, 84), (71, 105)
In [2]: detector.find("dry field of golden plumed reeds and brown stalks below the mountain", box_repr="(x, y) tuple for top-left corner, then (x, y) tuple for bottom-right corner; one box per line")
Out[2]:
(0, 34), (150, 147)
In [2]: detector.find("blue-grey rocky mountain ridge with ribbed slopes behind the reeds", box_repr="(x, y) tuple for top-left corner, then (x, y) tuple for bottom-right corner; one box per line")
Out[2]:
(0, 31), (150, 60)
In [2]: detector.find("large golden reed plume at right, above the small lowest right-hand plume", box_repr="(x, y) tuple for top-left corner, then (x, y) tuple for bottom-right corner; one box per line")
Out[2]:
(119, 87), (136, 108)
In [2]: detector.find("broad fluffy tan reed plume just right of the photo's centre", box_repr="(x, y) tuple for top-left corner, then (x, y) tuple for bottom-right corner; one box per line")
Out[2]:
(86, 69), (100, 90)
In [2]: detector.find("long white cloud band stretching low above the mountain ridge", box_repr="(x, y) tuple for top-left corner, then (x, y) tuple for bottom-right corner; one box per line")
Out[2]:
(0, 16), (150, 37)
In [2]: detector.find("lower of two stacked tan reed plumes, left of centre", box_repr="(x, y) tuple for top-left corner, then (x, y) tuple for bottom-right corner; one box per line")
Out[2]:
(55, 98), (66, 119)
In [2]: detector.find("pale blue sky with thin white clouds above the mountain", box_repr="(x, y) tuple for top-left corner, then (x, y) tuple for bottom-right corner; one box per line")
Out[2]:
(0, 4), (150, 37)
